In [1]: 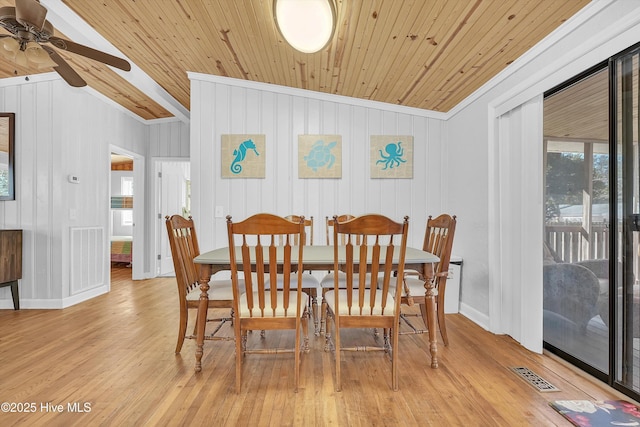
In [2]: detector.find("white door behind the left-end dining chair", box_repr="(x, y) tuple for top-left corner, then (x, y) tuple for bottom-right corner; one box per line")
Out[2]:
(156, 161), (190, 276)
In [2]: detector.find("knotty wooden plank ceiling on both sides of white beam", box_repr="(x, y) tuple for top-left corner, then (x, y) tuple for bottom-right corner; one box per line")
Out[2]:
(0, 0), (589, 119)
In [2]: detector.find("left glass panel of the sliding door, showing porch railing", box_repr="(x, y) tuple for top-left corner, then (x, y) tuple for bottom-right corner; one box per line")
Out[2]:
(543, 68), (611, 376)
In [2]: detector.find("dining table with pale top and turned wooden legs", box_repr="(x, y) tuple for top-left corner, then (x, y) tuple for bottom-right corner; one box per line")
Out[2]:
(194, 245), (440, 372)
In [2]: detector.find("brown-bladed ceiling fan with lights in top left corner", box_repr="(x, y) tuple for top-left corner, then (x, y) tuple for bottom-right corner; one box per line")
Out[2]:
(0, 0), (131, 87)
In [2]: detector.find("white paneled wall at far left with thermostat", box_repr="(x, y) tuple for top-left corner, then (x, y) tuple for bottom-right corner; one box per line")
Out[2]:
(0, 73), (146, 308)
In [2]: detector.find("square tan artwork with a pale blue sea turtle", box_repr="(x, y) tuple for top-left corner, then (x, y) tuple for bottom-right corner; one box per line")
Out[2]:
(298, 135), (342, 178)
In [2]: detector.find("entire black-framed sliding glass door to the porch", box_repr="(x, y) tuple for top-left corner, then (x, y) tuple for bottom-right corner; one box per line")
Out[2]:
(543, 46), (640, 400)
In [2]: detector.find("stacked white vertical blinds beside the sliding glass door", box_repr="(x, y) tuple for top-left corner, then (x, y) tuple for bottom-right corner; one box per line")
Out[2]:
(490, 95), (544, 353)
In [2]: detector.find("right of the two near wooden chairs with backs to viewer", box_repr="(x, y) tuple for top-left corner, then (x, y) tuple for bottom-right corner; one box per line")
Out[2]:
(325, 214), (409, 391)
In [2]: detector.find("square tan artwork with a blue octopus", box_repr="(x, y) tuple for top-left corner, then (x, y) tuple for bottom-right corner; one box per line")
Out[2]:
(369, 135), (413, 179)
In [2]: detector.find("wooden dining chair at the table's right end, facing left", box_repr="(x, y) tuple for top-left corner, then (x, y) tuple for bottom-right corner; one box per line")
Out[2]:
(400, 214), (457, 346)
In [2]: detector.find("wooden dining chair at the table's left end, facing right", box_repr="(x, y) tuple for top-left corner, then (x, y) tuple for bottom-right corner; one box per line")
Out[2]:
(165, 215), (243, 354)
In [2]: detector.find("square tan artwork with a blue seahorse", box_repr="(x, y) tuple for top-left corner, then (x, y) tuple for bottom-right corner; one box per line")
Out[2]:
(220, 134), (266, 178)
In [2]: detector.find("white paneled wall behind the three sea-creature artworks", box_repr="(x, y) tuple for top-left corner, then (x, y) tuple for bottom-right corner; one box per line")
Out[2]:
(190, 74), (444, 254)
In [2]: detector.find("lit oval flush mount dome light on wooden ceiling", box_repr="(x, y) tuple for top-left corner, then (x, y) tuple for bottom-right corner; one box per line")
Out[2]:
(273, 0), (336, 53)
